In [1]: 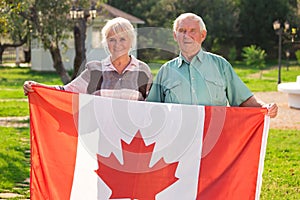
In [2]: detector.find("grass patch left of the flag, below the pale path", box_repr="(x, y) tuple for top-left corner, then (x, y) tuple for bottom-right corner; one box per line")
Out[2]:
(0, 127), (30, 197)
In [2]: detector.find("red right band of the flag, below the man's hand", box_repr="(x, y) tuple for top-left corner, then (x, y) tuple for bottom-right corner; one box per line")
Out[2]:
(197, 107), (266, 200)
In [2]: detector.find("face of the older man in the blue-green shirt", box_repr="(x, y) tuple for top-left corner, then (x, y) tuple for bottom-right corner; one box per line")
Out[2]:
(174, 18), (206, 56)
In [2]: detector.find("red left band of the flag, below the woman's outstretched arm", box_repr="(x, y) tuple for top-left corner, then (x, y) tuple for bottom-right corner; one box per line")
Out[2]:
(29, 87), (78, 200)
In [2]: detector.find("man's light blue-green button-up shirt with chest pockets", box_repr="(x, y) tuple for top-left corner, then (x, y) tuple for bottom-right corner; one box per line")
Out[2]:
(147, 50), (253, 106)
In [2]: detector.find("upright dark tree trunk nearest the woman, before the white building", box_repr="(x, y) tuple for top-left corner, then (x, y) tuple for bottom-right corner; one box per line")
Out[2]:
(72, 18), (87, 79)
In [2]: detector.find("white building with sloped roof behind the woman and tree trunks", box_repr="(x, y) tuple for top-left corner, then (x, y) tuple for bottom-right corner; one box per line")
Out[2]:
(31, 3), (144, 71)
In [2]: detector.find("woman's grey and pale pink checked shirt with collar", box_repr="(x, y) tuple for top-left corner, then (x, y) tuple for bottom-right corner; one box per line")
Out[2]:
(63, 55), (153, 101)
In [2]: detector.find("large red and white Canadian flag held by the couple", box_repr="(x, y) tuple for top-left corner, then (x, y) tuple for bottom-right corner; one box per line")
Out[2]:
(29, 87), (269, 200)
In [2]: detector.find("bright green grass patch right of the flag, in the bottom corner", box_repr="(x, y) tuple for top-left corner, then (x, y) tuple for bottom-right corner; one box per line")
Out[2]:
(261, 130), (300, 200)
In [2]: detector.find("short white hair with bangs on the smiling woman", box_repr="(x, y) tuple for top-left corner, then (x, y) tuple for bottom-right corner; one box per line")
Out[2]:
(101, 17), (136, 48)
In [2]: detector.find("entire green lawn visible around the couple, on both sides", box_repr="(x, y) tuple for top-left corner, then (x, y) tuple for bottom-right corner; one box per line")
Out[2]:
(0, 61), (300, 200)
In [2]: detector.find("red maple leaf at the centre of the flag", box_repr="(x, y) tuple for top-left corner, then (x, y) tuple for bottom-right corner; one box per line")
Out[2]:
(95, 131), (178, 200)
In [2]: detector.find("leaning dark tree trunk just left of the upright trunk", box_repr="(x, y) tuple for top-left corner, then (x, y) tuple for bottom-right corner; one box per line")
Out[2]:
(49, 45), (71, 84)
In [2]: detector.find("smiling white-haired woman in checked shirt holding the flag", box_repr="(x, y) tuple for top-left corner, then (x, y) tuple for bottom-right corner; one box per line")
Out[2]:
(23, 17), (152, 100)
